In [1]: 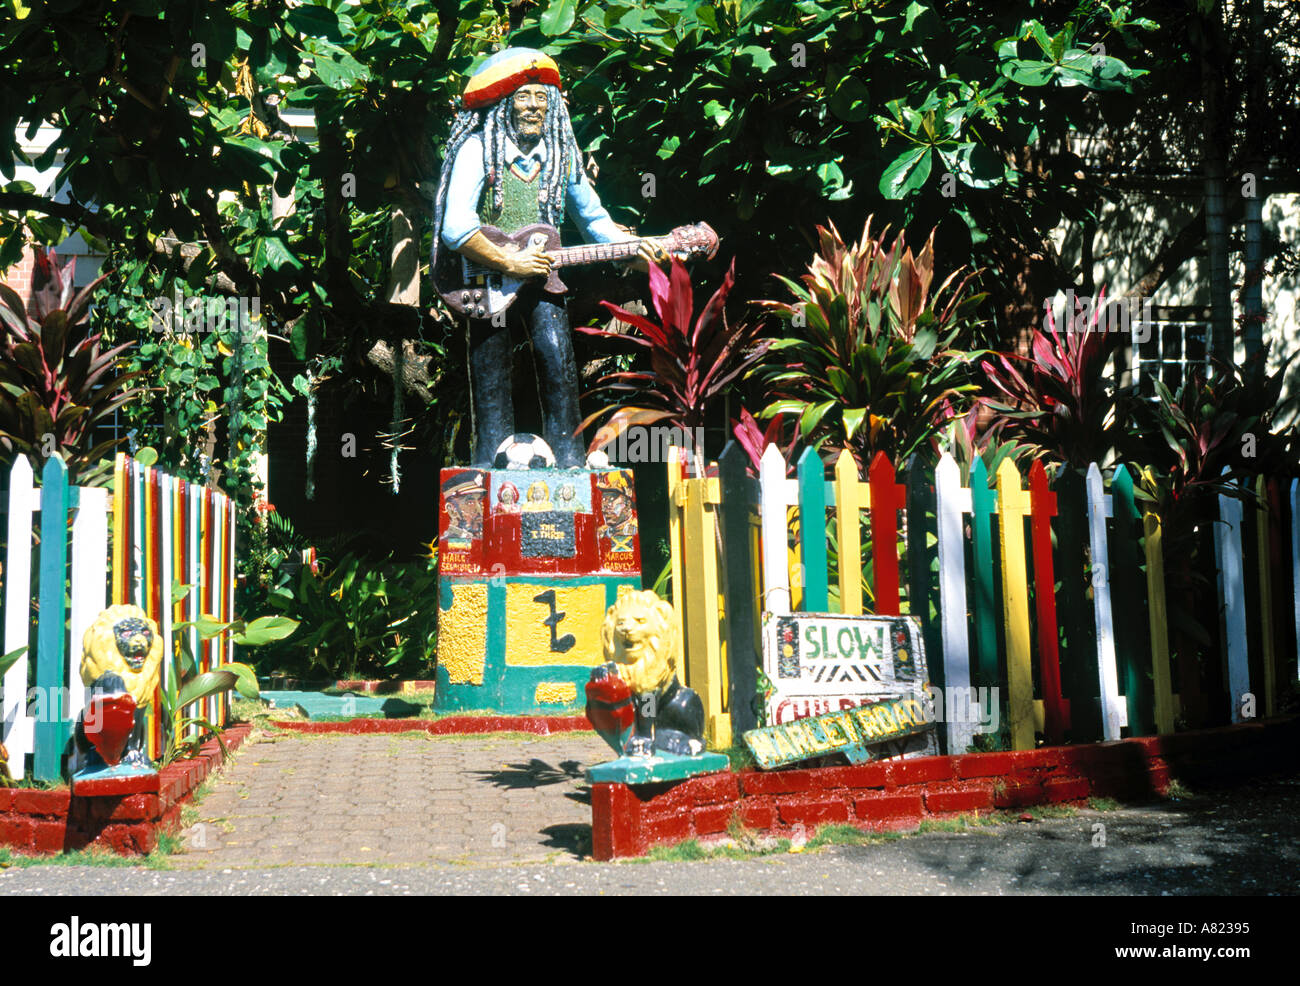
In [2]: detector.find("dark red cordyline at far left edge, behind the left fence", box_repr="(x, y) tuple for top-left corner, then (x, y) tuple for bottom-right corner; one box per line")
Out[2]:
(0, 248), (138, 485)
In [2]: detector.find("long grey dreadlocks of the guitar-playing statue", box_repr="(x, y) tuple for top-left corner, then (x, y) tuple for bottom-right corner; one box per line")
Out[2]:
(433, 86), (581, 264)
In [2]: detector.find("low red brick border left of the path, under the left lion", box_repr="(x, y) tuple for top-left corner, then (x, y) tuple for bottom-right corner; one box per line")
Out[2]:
(0, 723), (252, 856)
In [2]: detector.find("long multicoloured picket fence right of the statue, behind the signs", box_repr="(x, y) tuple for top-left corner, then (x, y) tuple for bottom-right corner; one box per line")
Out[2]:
(668, 442), (1300, 753)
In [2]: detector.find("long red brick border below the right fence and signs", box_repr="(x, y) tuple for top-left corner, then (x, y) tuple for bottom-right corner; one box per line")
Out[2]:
(592, 718), (1300, 860)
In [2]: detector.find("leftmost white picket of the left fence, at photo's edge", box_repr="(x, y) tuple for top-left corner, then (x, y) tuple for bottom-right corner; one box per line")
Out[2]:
(0, 455), (40, 780)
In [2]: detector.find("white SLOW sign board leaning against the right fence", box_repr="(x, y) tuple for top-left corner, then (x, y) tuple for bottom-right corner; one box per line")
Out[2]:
(763, 613), (930, 726)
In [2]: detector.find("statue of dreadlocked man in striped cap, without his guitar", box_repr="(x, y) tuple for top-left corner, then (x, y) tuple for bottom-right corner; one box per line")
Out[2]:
(434, 48), (667, 468)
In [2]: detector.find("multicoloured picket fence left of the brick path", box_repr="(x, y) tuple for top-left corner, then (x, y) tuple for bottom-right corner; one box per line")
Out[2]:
(3, 454), (235, 780)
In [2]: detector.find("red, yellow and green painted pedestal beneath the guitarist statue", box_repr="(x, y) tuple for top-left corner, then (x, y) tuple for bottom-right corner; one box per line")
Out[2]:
(434, 468), (641, 715)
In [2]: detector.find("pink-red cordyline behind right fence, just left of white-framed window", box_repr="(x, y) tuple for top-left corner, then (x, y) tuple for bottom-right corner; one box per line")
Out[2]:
(980, 287), (1121, 470)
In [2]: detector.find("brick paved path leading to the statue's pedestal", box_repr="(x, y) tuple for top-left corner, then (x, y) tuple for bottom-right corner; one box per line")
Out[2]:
(172, 732), (610, 869)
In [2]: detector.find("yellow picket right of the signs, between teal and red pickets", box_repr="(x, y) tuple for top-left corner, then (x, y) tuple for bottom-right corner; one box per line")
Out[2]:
(997, 459), (1034, 749)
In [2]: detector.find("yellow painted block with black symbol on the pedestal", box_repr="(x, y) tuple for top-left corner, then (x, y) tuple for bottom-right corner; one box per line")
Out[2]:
(506, 583), (606, 667)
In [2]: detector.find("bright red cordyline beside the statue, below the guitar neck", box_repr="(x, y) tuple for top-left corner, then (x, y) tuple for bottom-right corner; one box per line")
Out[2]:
(579, 258), (771, 475)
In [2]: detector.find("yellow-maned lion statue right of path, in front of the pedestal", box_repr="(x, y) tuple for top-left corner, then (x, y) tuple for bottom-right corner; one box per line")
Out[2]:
(586, 591), (705, 756)
